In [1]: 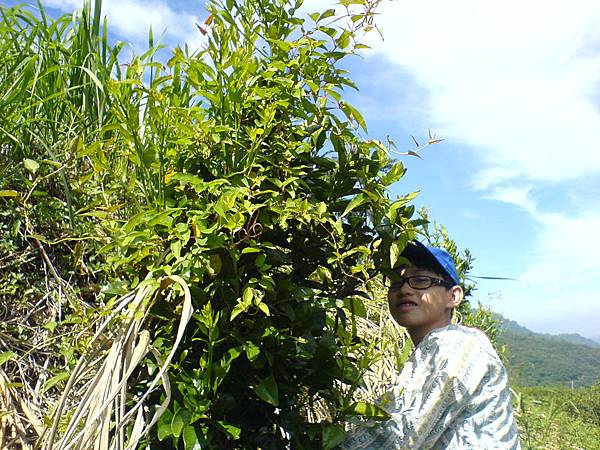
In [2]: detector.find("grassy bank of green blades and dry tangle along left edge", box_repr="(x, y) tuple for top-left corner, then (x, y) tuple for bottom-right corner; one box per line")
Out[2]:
(0, 0), (171, 448)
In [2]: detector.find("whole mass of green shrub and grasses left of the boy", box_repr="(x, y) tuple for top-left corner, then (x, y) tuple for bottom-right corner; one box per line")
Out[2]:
(0, 0), (452, 449)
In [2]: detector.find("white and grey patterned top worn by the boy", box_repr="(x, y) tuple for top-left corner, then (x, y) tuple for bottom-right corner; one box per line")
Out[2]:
(341, 325), (521, 450)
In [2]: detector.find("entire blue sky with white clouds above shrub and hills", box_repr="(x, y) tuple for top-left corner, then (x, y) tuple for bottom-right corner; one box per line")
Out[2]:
(24, 0), (600, 337)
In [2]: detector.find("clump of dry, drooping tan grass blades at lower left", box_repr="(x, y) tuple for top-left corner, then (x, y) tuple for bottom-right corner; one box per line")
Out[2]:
(44, 275), (193, 450)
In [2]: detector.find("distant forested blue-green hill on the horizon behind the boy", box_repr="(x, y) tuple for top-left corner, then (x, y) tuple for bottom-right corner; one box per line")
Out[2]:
(498, 316), (600, 386)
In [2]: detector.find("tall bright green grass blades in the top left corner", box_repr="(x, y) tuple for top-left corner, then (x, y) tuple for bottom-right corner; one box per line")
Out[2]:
(0, 0), (124, 151)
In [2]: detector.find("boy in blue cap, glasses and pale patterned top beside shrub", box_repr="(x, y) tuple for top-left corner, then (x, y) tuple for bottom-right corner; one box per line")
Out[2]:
(341, 241), (520, 450)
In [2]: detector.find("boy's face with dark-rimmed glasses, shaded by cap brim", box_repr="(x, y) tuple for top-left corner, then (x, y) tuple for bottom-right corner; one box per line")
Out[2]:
(388, 266), (462, 337)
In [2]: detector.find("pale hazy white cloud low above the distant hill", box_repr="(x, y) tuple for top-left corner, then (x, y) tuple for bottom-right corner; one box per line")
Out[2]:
(480, 188), (600, 336)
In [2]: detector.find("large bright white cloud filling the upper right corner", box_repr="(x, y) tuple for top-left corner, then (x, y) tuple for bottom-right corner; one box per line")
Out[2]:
(358, 0), (600, 186)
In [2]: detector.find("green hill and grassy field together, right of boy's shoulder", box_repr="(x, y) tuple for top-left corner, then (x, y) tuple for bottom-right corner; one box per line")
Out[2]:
(492, 314), (600, 450)
